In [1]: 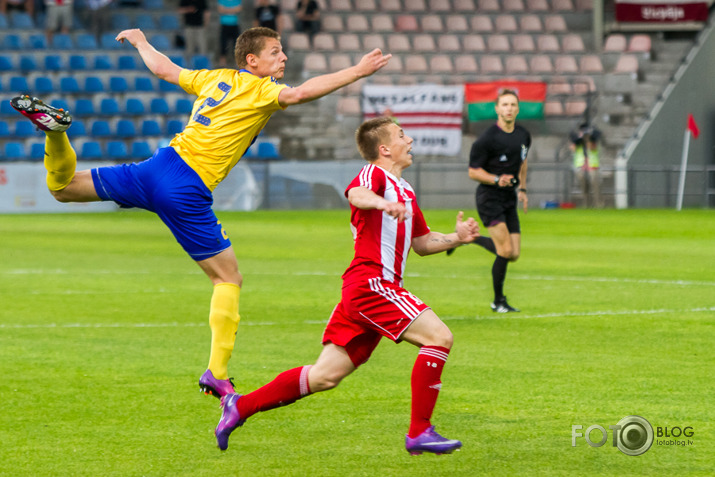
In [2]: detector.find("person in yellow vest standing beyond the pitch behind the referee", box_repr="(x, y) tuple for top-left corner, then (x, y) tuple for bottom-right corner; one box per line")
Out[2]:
(569, 123), (603, 208)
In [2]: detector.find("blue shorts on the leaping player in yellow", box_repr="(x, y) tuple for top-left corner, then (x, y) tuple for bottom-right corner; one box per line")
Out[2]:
(92, 147), (231, 261)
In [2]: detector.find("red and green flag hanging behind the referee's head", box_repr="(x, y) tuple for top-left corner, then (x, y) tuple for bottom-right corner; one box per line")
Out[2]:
(464, 80), (546, 121)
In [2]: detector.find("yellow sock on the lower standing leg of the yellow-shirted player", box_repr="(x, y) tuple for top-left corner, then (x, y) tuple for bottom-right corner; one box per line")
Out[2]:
(209, 283), (241, 379)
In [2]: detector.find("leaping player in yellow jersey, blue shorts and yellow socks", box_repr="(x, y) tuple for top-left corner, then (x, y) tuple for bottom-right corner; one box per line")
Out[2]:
(11, 27), (391, 398)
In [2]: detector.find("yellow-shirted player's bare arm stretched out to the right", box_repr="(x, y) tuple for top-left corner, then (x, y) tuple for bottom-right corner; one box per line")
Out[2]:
(278, 48), (392, 107)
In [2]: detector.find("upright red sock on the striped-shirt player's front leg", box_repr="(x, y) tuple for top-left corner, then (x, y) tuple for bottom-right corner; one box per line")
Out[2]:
(406, 346), (449, 438)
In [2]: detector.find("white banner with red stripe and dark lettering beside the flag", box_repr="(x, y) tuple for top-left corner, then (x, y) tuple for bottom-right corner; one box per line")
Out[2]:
(362, 84), (464, 156)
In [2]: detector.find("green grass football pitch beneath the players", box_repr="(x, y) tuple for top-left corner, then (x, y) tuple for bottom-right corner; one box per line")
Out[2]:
(0, 210), (715, 477)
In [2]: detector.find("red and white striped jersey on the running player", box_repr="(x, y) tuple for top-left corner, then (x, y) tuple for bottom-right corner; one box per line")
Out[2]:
(343, 164), (430, 286)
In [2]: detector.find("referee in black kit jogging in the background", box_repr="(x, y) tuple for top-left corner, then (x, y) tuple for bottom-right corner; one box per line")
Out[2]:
(448, 89), (531, 313)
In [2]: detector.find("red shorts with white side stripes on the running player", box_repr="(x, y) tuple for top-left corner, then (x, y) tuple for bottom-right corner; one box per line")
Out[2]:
(323, 278), (430, 367)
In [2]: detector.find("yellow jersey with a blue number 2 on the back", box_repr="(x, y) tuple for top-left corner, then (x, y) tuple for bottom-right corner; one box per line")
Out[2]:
(169, 69), (286, 190)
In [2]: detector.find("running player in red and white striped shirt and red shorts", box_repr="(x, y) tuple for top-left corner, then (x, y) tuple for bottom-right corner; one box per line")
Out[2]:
(216, 117), (479, 454)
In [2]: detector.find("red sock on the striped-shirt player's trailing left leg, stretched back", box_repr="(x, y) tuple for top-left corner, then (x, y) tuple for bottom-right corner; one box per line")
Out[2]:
(236, 366), (310, 419)
